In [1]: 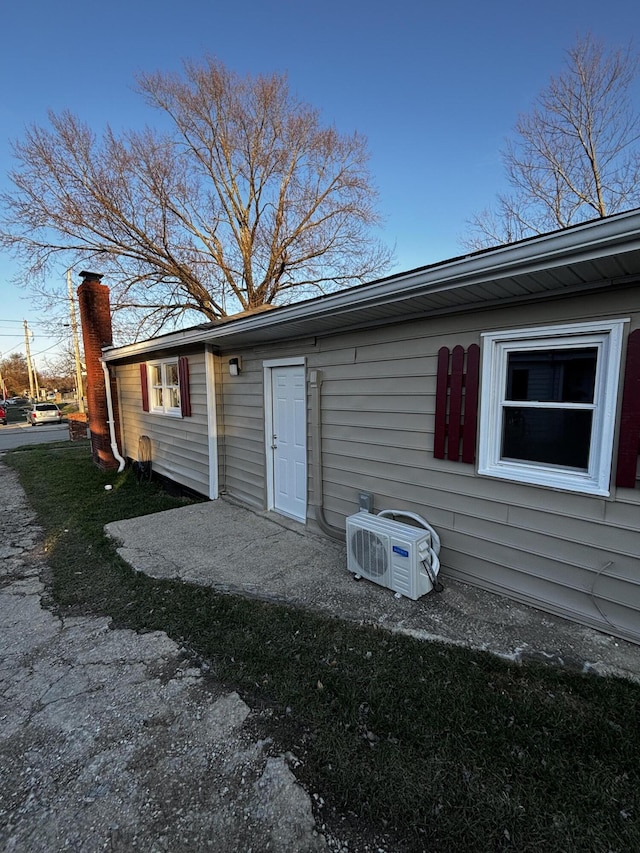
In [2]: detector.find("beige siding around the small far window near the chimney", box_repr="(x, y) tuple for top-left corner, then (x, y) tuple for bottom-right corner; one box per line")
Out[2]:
(116, 352), (209, 495)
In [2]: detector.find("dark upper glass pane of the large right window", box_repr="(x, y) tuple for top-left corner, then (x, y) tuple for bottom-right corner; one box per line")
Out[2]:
(505, 347), (598, 403)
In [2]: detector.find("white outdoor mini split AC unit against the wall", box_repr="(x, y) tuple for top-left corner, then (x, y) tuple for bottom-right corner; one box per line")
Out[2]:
(347, 510), (442, 601)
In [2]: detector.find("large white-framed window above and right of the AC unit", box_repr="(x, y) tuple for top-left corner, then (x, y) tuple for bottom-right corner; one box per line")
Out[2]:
(478, 320), (625, 495)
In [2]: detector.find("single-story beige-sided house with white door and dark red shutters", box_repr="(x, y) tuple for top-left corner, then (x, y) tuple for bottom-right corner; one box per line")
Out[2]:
(80, 210), (640, 642)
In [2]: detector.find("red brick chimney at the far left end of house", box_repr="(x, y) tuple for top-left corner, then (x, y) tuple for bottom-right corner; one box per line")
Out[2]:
(78, 271), (120, 471)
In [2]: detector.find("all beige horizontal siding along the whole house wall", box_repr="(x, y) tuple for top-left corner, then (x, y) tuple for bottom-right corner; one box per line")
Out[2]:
(112, 289), (640, 641)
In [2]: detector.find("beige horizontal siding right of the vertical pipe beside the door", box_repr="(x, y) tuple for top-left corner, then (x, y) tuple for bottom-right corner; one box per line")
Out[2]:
(292, 292), (640, 640)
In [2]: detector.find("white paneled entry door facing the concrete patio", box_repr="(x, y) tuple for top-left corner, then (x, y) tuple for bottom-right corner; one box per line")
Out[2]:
(267, 364), (307, 521)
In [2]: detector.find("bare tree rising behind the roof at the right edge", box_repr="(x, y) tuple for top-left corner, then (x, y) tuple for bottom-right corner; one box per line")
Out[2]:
(464, 35), (640, 248)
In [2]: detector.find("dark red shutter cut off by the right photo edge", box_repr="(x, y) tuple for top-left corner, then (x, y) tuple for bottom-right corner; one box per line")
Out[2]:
(616, 329), (640, 489)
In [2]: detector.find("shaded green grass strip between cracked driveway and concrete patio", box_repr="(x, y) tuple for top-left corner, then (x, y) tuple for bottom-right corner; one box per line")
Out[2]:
(6, 442), (640, 853)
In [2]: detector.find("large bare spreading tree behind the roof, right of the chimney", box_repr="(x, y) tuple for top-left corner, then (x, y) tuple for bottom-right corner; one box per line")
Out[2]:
(0, 58), (391, 334)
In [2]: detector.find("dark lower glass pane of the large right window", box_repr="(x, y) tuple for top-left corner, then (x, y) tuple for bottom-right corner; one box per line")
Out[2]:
(501, 406), (593, 471)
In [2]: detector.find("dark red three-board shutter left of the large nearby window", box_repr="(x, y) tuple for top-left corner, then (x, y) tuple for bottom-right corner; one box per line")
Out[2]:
(433, 344), (480, 464)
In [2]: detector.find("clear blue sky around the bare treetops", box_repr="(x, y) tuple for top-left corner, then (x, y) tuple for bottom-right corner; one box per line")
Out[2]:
(0, 0), (640, 364)
